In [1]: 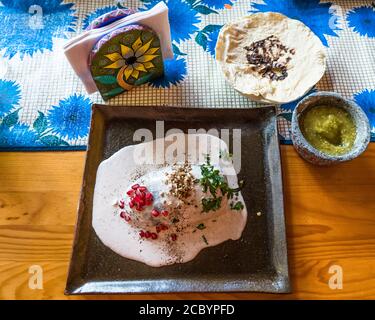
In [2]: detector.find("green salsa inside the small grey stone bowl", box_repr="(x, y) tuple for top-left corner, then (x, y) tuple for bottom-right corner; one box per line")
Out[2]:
(300, 105), (356, 156)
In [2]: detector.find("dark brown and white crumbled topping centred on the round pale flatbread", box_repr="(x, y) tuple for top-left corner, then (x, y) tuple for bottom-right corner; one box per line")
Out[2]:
(244, 35), (296, 81)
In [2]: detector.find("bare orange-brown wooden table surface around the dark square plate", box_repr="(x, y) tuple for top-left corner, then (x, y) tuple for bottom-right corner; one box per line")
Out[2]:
(0, 144), (375, 299)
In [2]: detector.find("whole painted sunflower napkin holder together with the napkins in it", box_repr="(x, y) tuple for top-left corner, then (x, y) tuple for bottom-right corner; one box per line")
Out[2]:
(64, 2), (173, 100)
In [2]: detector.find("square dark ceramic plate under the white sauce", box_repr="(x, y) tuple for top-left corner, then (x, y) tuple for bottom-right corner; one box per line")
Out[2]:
(65, 105), (290, 294)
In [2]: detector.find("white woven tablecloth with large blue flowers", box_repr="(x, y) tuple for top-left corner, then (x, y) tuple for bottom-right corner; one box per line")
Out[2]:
(0, 0), (375, 150)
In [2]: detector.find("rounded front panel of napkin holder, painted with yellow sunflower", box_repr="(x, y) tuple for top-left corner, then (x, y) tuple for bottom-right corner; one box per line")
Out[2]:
(90, 25), (164, 100)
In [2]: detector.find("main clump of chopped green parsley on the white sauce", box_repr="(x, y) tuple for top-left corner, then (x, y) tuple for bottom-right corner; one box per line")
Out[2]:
(199, 155), (243, 212)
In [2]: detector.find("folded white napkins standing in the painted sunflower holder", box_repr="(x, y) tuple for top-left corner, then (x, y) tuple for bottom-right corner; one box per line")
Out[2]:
(63, 2), (173, 94)
